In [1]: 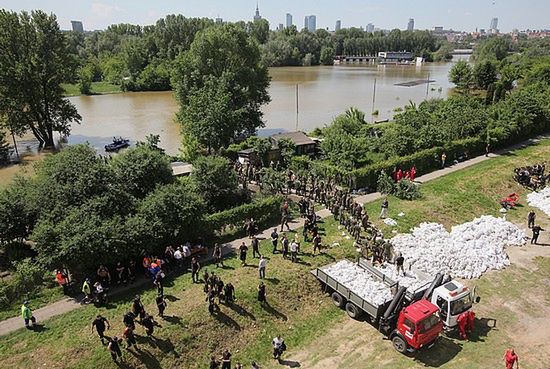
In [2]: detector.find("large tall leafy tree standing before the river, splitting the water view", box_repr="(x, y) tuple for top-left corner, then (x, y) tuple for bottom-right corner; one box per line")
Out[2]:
(172, 25), (270, 150)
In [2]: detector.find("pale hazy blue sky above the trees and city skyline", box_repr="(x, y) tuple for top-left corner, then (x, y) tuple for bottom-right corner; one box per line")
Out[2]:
(0, 0), (550, 32)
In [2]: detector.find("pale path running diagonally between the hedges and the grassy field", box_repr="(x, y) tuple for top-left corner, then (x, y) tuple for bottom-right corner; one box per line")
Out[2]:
(0, 135), (550, 336)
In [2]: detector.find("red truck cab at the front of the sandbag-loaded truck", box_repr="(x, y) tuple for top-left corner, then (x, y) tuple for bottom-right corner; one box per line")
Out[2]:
(390, 300), (443, 353)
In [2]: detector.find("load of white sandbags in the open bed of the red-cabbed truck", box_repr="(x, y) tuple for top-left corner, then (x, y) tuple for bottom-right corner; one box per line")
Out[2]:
(323, 260), (392, 305)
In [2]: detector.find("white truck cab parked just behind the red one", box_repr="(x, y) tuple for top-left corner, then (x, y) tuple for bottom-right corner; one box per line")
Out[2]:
(431, 280), (479, 330)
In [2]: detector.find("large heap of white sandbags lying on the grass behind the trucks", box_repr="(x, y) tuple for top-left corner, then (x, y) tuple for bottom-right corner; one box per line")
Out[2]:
(391, 216), (526, 278)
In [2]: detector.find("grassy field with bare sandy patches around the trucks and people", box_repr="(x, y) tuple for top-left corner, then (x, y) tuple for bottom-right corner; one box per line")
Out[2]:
(0, 140), (550, 369)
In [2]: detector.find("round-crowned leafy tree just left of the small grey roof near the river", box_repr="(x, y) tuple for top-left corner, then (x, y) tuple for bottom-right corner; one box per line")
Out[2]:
(110, 145), (174, 199)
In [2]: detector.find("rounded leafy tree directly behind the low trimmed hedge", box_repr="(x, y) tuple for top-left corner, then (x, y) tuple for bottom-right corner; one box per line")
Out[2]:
(191, 156), (244, 211)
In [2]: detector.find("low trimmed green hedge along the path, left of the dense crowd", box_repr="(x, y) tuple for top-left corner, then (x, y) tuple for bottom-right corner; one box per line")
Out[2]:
(206, 196), (283, 234)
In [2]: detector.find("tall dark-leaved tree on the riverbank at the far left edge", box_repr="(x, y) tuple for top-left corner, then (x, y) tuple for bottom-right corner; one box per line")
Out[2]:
(0, 9), (81, 147)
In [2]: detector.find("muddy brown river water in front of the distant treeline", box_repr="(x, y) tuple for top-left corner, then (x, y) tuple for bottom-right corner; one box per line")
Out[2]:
(0, 62), (462, 183)
